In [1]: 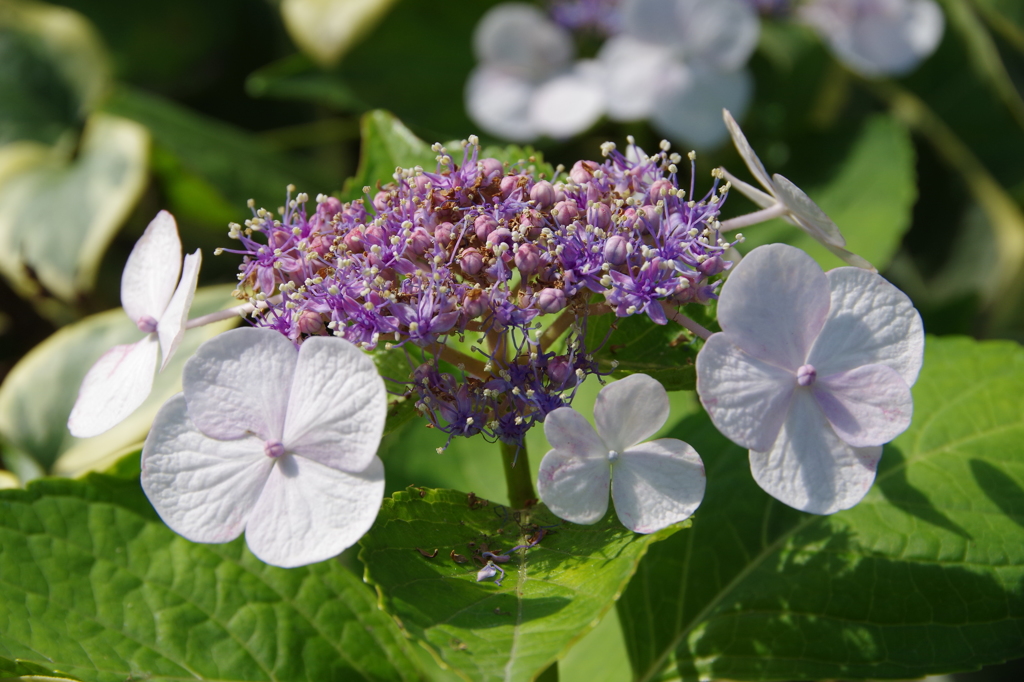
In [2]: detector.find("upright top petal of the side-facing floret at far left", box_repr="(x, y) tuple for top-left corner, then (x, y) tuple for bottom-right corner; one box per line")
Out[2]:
(121, 211), (181, 323)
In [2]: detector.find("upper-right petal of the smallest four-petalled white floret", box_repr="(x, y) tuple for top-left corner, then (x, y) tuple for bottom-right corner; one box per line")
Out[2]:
(598, 374), (669, 453)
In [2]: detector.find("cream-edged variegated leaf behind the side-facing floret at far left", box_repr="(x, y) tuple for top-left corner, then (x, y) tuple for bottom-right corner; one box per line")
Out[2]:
(0, 286), (238, 475)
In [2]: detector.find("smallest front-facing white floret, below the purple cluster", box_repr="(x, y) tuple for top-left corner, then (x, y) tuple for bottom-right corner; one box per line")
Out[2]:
(538, 374), (706, 532)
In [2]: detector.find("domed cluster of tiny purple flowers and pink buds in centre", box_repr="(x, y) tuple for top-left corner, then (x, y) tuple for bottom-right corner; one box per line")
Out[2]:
(225, 139), (731, 445)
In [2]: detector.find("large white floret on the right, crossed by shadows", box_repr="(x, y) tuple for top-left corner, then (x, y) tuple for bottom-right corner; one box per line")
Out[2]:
(696, 244), (925, 514)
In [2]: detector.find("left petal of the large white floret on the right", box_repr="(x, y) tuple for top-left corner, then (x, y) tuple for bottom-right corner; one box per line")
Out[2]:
(696, 334), (797, 451)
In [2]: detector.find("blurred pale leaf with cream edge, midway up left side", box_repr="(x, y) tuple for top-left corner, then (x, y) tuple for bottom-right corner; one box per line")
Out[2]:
(0, 114), (150, 302)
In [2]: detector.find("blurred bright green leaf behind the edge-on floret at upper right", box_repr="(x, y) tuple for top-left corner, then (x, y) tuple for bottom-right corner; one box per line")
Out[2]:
(741, 116), (918, 269)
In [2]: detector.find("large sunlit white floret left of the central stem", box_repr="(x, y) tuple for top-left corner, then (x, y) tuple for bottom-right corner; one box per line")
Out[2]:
(142, 328), (387, 567)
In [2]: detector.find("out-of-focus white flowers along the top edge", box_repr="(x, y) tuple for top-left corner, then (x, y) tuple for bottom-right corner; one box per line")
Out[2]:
(466, 0), (944, 148)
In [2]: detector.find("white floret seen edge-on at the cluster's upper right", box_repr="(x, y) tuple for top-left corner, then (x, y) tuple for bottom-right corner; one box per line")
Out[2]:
(722, 109), (877, 272)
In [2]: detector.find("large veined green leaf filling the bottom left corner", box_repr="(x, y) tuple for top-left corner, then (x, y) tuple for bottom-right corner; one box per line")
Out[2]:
(0, 474), (421, 682)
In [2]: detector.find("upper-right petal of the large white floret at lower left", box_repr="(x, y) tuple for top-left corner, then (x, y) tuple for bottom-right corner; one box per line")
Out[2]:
(282, 336), (387, 471)
